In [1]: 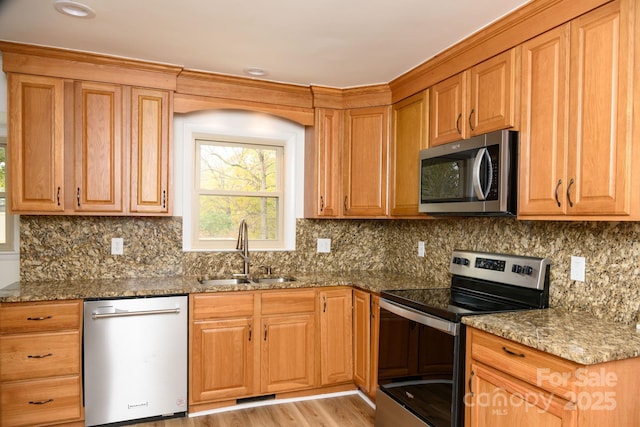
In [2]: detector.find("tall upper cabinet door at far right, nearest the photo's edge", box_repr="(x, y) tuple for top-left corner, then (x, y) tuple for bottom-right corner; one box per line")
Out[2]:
(566, 2), (633, 215)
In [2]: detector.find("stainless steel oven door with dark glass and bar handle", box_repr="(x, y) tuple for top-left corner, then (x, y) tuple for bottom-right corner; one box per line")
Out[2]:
(375, 299), (464, 427)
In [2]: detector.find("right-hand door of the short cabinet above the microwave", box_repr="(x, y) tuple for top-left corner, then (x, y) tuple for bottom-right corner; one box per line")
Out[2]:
(465, 48), (520, 136)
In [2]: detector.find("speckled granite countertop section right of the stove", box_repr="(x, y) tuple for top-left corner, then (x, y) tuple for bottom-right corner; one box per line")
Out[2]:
(462, 308), (640, 365)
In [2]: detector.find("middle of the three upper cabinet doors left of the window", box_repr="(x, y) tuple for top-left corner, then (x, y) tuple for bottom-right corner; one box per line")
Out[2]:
(73, 82), (123, 212)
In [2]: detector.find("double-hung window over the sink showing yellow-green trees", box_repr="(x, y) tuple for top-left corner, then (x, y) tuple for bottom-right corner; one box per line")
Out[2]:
(192, 136), (285, 249)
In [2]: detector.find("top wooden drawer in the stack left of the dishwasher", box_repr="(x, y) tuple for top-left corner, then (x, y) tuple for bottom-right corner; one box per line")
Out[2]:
(0, 301), (82, 334)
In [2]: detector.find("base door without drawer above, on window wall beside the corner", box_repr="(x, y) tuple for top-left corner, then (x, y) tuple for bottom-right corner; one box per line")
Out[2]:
(320, 289), (353, 385)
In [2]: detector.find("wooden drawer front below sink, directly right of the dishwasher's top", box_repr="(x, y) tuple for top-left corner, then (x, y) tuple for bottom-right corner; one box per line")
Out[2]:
(191, 292), (254, 320)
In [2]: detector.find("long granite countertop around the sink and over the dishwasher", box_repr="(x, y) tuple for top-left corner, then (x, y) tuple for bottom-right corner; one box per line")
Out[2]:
(0, 271), (442, 302)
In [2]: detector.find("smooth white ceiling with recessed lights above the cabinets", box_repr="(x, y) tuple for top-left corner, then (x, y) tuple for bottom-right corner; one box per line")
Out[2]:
(0, 0), (527, 88)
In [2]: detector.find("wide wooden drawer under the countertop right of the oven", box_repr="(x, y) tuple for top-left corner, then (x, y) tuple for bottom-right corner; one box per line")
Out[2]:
(471, 330), (579, 398)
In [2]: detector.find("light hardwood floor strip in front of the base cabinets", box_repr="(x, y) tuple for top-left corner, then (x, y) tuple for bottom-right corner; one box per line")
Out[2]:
(133, 394), (374, 427)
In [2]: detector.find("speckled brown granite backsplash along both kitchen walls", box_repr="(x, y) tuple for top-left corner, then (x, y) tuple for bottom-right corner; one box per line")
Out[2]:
(20, 216), (640, 323)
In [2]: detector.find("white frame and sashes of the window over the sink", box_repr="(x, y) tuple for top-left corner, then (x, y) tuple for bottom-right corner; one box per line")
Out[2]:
(191, 133), (287, 251)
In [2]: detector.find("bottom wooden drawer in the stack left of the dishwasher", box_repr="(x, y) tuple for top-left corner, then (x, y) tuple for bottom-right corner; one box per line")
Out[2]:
(0, 375), (82, 426)
